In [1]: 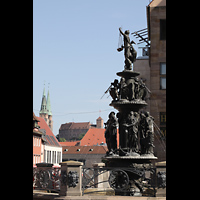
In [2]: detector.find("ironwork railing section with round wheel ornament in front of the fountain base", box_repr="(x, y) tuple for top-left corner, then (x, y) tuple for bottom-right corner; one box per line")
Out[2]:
(82, 167), (157, 196)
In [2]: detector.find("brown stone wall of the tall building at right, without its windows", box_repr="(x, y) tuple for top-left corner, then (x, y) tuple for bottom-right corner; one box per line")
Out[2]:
(149, 6), (166, 161)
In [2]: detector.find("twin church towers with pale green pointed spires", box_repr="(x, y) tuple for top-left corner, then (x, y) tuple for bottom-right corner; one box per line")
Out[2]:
(39, 84), (53, 132)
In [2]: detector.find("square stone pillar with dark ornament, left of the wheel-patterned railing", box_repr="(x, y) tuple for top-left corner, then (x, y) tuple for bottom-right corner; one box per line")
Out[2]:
(59, 160), (83, 196)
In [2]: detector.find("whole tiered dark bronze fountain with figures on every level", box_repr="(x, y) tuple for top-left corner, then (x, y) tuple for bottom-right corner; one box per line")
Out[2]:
(103, 28), (157, 197)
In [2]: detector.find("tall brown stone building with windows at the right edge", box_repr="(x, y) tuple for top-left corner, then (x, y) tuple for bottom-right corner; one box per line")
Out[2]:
(147, 0), (166, 161)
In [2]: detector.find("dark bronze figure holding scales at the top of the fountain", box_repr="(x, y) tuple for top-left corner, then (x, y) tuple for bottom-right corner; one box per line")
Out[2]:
(117, 28), (137, 70)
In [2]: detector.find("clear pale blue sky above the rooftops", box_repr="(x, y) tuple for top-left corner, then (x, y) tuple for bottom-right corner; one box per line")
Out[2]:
(33, 0), (150, 135)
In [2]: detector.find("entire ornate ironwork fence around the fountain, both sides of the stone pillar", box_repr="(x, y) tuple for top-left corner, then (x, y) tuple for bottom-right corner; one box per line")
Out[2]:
(33, 162), (166, 196)
